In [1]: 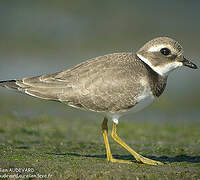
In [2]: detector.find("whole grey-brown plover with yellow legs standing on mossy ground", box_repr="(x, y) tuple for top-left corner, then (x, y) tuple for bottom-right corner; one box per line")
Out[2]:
(0, 37), (197, 165)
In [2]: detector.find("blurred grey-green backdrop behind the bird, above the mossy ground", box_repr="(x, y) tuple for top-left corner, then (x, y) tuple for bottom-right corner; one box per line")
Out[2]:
(0, 0), (200, 123)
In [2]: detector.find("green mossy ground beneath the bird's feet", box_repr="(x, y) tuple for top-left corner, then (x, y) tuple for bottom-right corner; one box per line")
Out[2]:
(0, 115), (200, 179)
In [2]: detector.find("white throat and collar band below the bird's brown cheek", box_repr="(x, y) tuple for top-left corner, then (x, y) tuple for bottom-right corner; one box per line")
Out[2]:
(137, 54), (183, 76)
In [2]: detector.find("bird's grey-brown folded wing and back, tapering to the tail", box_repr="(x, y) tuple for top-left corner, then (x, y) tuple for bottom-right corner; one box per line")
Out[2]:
(0, 53), (145, 111)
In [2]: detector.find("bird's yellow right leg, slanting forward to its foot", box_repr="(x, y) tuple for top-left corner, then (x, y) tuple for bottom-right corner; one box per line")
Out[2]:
(111, 123), (163, 165)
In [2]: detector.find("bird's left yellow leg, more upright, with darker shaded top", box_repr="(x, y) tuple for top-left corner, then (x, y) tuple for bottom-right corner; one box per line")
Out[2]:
(101, 118), (132, 164)
